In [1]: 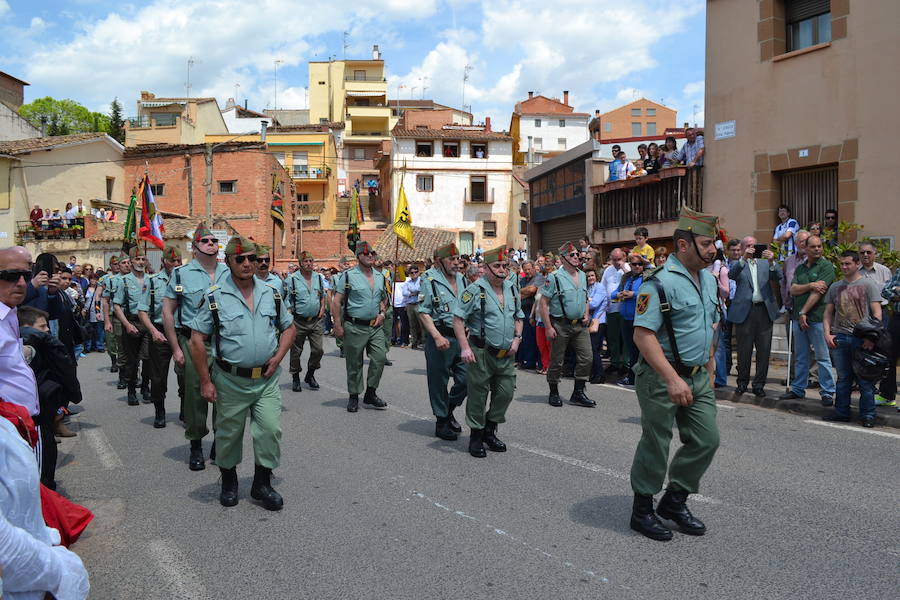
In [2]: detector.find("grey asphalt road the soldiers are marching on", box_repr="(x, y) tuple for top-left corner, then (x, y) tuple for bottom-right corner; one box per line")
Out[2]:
(57, 338), (900, 599)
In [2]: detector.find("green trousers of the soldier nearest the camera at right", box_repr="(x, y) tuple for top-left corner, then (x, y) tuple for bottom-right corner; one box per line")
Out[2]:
(631, 360), (719, 496)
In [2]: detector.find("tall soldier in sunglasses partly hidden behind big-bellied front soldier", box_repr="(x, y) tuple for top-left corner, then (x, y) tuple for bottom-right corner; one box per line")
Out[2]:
(163, 221), (228, 471)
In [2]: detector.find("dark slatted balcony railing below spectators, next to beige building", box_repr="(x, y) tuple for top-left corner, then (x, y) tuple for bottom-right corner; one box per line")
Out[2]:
(591, 167), (703, 231)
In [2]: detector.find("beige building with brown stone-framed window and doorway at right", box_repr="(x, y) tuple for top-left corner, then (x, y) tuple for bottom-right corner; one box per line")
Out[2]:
(703, 0), (900, 247)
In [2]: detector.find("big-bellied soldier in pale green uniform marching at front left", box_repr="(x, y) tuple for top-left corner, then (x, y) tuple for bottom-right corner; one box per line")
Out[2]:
(190, 236), (295, 510)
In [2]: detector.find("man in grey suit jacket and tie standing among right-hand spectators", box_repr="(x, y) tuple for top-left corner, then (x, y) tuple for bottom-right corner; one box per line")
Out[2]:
(728, 236), (781, 398)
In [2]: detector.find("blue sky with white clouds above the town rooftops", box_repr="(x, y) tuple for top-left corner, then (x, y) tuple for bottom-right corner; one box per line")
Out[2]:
(0, 0), (705, 129)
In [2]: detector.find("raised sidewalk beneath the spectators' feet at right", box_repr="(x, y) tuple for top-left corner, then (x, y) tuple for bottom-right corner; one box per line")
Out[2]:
(715, 357), (900, 429)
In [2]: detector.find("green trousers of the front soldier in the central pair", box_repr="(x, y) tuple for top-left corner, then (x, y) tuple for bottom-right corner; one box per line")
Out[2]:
(466, 346), (516, 429)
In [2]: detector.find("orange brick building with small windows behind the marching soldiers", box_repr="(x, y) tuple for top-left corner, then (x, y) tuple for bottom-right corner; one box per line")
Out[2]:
(124, 142), (298, 263)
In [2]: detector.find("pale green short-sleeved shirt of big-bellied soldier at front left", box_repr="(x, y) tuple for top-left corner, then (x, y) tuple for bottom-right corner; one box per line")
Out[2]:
(189, 275), (294, 369)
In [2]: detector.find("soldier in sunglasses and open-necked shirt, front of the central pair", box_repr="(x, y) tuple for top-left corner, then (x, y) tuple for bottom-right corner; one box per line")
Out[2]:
(453, 245), (525, 458)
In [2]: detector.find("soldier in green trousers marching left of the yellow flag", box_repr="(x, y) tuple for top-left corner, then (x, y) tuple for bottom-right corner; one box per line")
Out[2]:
(331, 241), (388, 413)
